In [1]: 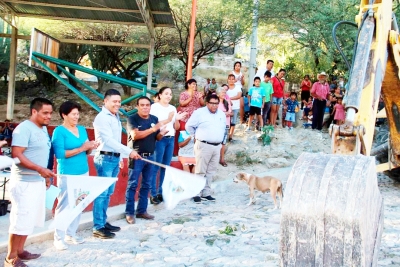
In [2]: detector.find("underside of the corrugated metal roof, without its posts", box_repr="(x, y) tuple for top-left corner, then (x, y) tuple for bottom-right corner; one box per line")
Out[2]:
(3, 0), (175, 27)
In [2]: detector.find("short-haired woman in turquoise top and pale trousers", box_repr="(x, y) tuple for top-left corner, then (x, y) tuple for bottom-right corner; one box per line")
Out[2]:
(52, 101), (98, 250)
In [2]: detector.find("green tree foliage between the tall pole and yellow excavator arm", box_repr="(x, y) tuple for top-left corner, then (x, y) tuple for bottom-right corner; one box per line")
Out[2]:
(260, 0), (359, 77)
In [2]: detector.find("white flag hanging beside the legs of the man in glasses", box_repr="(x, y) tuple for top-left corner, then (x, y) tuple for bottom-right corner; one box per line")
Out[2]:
(162, 166), (206, 210)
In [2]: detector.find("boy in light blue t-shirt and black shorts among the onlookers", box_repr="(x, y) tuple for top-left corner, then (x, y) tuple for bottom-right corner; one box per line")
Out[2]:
(246, 77), (265, 131)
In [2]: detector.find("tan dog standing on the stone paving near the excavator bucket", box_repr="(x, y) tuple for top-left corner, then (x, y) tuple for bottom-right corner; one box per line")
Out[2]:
(233, 172), (283, 209)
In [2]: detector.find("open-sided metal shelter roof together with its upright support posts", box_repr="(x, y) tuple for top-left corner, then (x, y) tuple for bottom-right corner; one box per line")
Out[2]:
(0, 0), (175, 119)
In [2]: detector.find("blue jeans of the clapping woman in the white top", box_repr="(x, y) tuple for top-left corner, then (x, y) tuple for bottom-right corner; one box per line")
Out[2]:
(151, 137), (174, 197)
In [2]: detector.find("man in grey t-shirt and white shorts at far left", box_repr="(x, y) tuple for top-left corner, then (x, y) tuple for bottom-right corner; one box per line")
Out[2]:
(4, 98), (56, 267)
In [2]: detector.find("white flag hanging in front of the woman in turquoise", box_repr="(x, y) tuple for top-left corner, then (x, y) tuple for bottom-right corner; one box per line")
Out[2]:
(49, 175), (118, 231)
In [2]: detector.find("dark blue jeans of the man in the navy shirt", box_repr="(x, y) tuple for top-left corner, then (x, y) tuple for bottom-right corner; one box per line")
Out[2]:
(125, 156), (155, 216)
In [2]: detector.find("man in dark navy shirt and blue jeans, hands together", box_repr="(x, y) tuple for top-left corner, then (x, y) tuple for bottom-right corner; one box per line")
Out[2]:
(125, 96), (168, 224)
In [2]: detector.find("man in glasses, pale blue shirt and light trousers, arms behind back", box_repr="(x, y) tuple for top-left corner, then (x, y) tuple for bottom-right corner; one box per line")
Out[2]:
(186, 94), (226, 204)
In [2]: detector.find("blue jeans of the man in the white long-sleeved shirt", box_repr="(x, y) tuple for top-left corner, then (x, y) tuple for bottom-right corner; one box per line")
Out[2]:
(93, 154), (119, 230)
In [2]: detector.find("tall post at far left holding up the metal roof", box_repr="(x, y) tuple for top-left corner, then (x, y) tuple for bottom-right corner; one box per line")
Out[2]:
(7, 24), (18, 120)
